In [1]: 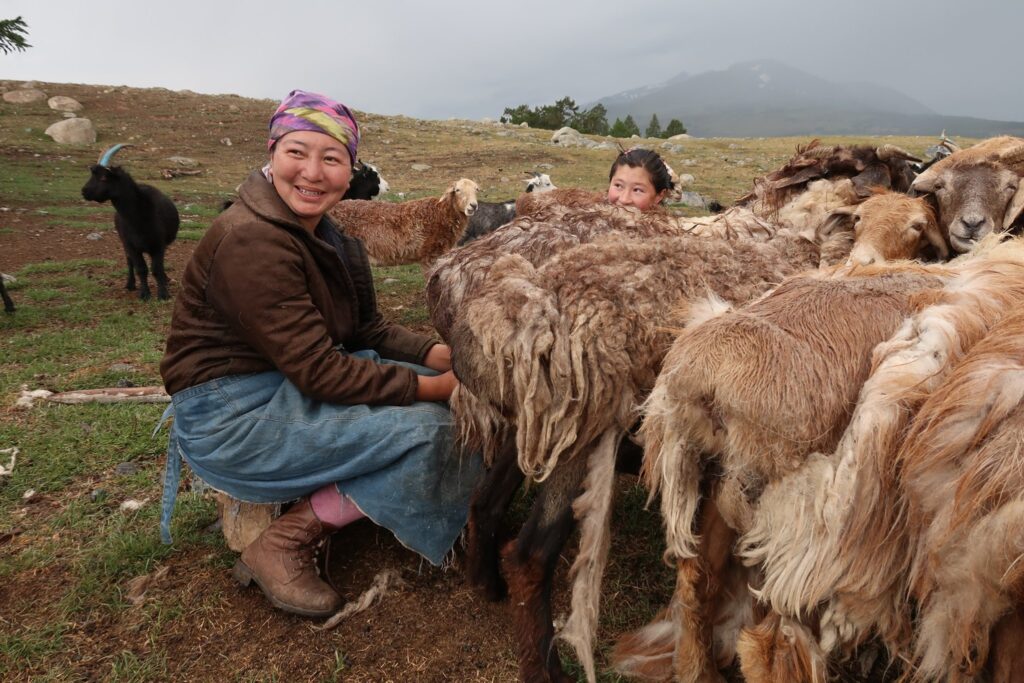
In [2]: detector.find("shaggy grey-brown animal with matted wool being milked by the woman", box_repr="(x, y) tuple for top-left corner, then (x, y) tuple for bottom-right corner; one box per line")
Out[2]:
(452, 233), (818, 680)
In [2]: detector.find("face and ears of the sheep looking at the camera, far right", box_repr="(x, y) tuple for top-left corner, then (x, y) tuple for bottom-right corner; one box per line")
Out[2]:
(912, 161), (1024, 253)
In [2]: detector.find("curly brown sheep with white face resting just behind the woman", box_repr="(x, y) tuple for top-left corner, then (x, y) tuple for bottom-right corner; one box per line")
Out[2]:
(329, 178), (479, 265)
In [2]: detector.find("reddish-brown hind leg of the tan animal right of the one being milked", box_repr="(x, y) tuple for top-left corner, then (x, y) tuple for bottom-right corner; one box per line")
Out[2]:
(672, 498), (736, 683)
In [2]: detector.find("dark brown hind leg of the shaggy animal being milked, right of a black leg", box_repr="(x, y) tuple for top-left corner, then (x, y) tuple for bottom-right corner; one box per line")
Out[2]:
(502, 456), (587, 683)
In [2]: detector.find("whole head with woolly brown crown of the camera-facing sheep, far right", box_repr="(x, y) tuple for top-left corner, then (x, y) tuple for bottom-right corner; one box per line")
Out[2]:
(912, 136), (1024, 253)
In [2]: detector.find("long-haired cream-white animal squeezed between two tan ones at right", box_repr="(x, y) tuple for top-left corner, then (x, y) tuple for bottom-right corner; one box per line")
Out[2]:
(738, 239), (1024, 671)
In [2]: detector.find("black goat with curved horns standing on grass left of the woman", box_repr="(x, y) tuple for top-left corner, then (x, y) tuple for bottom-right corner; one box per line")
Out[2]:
(82, 144), (179, 299)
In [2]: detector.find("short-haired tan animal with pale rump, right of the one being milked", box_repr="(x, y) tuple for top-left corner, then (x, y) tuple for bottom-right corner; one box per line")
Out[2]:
(626, 236), (1024, 681)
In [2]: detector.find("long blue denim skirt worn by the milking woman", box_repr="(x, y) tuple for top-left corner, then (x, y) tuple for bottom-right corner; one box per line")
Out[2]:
(161, 351), (482, 564)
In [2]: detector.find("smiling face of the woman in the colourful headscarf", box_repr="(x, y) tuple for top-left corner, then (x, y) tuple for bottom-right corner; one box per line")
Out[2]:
(270, 130), (352, 231)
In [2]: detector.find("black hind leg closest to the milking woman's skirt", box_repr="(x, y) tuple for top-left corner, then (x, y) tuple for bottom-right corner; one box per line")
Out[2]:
(466, 433), (523, 602)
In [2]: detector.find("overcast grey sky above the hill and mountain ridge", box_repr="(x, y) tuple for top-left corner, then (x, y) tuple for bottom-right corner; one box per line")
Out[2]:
(0, 0), (1024, 121)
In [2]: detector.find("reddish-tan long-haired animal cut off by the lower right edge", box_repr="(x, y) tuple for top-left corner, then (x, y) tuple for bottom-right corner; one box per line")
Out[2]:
(901, 312), (1024, 683)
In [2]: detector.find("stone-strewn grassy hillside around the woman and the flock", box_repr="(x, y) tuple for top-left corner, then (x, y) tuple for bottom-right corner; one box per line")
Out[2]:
(0, 82), (958, 681)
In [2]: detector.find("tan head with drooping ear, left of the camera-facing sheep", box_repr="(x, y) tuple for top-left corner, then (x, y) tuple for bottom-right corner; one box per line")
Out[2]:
(847, 193), (949, 265)
